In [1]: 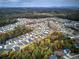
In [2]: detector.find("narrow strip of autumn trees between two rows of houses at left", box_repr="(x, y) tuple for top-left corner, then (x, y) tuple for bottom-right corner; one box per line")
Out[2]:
(0, 25), (33, 43)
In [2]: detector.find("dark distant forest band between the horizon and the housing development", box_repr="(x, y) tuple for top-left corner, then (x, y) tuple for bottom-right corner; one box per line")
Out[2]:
(0, 7), (79, 21)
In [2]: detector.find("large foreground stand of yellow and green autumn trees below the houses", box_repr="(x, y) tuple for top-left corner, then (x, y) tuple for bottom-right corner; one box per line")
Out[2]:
(1, 32), (78, 59)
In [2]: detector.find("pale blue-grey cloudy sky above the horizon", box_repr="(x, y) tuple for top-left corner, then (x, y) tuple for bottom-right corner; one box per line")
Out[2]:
(0, 0), (79, 7)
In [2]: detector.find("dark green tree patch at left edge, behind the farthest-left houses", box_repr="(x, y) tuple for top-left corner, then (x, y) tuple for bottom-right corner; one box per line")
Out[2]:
(0, 16), (17, 27)
